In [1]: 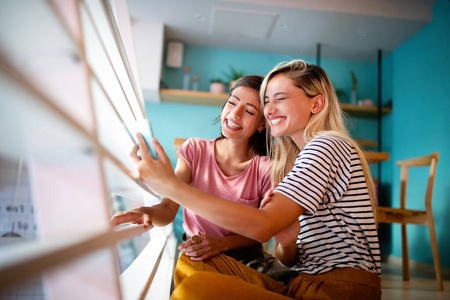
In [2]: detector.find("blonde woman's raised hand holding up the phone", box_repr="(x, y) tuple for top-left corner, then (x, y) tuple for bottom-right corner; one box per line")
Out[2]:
(130, 133), (177, 195)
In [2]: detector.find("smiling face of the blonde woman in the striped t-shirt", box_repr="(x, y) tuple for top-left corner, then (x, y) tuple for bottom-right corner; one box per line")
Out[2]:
(264, 73), (316, 149)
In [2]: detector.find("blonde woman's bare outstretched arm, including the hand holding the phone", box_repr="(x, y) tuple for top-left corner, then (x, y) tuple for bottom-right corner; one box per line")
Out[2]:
(131, 134), (304, 242)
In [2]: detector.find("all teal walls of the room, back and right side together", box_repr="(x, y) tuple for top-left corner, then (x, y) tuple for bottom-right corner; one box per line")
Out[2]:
(146, 8), (450, 260)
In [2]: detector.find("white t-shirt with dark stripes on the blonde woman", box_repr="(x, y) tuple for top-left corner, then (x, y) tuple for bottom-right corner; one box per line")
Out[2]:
(275, 136), (380, 275)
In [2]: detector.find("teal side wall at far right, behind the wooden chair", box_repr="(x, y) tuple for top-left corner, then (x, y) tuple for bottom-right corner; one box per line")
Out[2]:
(389, 0), (450, 267)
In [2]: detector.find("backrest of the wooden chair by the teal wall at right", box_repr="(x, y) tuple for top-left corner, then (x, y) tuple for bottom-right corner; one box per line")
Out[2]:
(397, 152), (439, 211)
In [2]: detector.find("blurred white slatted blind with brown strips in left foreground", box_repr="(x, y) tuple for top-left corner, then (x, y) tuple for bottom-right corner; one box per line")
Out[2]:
(0, 0), (176, 299)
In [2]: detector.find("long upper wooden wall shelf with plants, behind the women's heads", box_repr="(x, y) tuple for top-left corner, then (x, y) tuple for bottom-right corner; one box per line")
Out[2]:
(160, 89), (392, 119)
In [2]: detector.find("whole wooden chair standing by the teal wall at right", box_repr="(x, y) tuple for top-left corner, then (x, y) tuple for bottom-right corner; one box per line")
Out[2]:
(376, 152), (444, 291)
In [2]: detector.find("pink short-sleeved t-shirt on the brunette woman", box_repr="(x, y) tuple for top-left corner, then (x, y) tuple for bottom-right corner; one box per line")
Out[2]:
(178, 138), (271, 237)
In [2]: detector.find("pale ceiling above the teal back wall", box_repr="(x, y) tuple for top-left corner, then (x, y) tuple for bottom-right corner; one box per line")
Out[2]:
(128, 0), (436, 61)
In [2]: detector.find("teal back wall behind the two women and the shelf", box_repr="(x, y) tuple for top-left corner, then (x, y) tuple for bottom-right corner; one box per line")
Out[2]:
(146, 46), (390, 244)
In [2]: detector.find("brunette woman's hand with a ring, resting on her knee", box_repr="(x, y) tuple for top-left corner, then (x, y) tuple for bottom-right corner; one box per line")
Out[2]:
(178, 235), (224, 261)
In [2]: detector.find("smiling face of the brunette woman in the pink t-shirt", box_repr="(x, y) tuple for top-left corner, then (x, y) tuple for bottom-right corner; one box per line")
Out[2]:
(220, 86), (264, 140)
